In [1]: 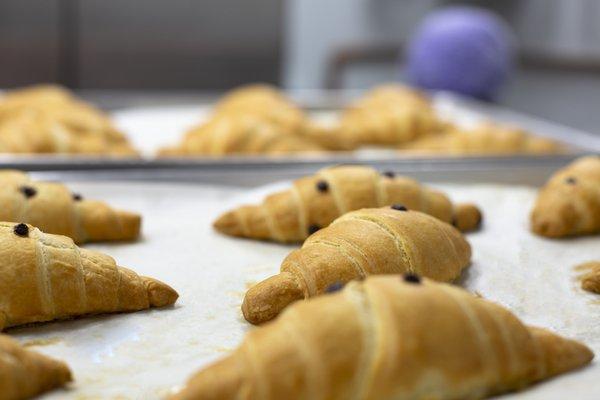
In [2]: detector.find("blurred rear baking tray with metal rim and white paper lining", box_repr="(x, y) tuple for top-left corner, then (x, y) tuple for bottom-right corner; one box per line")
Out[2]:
(0, 91), (600, 171)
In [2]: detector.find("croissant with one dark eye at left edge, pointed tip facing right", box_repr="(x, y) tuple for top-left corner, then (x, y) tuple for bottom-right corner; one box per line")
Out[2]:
(0, 222), (178, 330)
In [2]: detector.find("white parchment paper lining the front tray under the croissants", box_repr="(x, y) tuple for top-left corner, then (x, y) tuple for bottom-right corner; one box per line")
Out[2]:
(8, 176), (600, 400)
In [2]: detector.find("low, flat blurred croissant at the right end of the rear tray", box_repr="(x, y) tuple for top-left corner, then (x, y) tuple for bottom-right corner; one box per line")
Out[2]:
(403, 123), (563, 155)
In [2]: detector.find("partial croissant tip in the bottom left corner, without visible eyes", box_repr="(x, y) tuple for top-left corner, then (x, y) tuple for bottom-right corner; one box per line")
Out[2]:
(0, 335), (71, 400)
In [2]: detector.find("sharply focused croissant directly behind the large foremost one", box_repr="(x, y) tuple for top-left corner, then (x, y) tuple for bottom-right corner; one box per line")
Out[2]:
(242, 206), (471, 324)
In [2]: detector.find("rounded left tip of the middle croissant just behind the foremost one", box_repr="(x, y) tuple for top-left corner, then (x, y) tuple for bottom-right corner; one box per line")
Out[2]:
(242, 272), (304, 325)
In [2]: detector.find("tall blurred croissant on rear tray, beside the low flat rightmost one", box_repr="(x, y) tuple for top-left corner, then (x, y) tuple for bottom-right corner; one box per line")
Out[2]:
(340, 85), (439, 146)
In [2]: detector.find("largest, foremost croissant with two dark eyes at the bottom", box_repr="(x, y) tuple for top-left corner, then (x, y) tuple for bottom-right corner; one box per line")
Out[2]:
(172, 275), (593, 400)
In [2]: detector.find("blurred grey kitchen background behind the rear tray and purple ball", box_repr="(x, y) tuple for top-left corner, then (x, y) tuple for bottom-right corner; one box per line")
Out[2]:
(0, 0), (600, 132)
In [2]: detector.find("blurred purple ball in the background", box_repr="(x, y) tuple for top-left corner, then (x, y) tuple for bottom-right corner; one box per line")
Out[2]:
(407, 7), (513, 100)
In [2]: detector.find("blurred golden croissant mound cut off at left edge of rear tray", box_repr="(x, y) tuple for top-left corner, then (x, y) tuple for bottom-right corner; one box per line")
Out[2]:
(0, 85), (137, 156)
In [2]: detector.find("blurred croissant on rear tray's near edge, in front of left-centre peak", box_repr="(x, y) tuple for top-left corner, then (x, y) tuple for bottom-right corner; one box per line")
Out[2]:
(160, 114), (321, 156)
